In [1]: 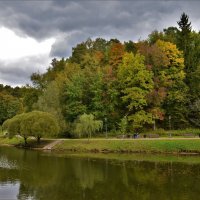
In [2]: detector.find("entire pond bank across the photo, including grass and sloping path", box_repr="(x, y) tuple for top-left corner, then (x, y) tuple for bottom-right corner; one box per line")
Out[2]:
(0, 138), (200, 156)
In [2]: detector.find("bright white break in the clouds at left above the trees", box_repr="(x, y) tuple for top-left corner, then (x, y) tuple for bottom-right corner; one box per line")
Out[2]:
(0, 27), (55, 86)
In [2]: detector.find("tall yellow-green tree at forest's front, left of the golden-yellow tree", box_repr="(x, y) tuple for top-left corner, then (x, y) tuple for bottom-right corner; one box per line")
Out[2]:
(118, 53), (153, 127)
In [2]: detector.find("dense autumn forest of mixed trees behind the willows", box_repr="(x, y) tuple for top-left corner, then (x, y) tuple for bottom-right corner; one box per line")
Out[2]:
(0, 13), (200, 136)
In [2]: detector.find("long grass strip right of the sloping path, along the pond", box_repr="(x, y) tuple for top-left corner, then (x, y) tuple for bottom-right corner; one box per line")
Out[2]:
(53, 138), (200, 154)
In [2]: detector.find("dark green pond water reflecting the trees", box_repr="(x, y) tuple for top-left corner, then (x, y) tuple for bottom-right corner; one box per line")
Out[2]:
(0, 147), (200, 200)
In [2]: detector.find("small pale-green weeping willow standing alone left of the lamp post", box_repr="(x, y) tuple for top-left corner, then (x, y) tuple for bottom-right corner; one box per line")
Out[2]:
(75, 113), (103, 140)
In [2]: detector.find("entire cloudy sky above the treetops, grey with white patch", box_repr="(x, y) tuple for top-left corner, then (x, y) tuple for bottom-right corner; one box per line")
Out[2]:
(0, 0), (200, 86)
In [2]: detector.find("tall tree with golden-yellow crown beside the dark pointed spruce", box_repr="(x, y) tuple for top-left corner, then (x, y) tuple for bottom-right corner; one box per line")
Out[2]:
(156, 40), (188, 127)
